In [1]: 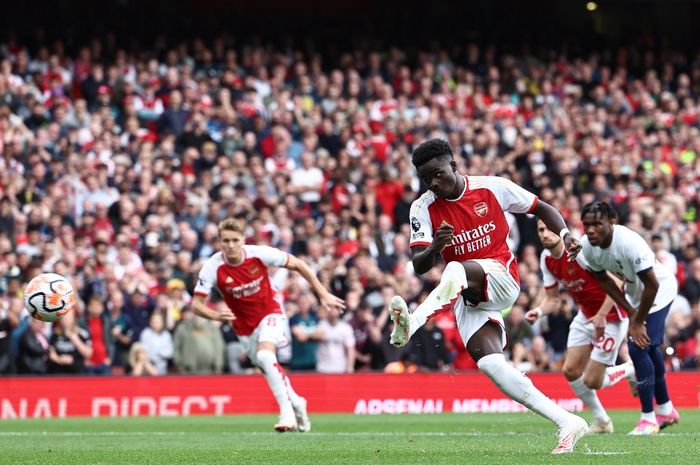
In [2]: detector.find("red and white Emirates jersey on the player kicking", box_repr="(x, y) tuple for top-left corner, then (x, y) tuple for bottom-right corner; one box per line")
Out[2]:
(411, 176), (537, 280)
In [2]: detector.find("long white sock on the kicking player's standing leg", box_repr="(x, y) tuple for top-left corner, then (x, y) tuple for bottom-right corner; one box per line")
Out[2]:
(477, 354), (571, 427)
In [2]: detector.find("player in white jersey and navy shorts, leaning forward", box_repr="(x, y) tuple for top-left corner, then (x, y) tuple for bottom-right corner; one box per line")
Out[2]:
(581, 202), (680, 436)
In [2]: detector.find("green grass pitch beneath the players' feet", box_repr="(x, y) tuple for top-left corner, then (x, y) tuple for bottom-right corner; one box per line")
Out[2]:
(0, 410), (700, 465)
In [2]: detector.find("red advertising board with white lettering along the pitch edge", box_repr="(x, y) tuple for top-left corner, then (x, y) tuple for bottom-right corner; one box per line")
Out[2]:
(0, 372), (700, 419)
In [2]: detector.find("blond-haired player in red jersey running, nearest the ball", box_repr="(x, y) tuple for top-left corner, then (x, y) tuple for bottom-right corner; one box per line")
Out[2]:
(192, 219), (345, 432)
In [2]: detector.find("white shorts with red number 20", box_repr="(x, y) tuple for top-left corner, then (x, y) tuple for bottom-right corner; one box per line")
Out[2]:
(566, 310), (629, 365)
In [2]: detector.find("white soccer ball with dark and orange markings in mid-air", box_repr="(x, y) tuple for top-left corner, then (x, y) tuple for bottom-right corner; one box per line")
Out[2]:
(24, 273), (75, 321)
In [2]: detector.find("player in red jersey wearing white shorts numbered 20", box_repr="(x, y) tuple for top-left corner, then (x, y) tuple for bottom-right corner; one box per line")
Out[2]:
(525, 221), (634, 433)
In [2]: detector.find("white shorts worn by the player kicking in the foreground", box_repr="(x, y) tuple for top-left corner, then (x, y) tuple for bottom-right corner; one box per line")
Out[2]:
(454, 259), (520, 348)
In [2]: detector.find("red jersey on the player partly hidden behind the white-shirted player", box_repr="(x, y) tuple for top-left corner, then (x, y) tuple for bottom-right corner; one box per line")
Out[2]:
(540, 249), (627, 321)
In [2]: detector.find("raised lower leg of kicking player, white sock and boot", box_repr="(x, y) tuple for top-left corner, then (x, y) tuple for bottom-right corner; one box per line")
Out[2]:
(389, 262), (469, 347)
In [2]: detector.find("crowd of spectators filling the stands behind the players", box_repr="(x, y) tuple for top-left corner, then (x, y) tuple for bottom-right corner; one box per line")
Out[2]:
(0, 37), (700, 375)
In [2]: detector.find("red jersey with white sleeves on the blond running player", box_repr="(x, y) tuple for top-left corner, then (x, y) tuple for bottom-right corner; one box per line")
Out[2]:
(194, 245), (288, 336)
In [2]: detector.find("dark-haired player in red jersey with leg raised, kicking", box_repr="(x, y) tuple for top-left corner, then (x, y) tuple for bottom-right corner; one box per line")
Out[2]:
(390, 139), (588, 454)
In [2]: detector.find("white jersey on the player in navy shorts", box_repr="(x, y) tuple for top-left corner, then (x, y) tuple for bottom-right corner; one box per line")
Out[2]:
(581, 224), (678, 313)
